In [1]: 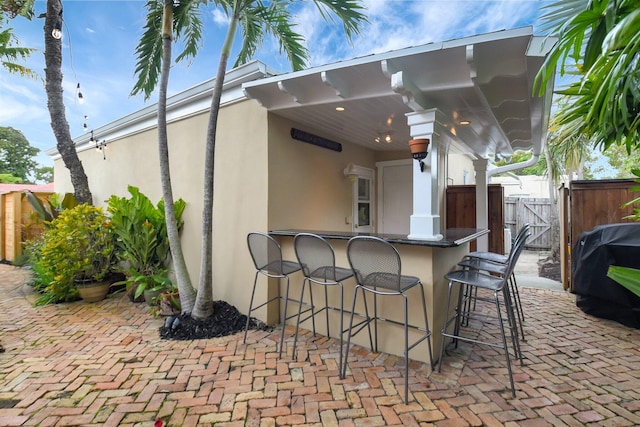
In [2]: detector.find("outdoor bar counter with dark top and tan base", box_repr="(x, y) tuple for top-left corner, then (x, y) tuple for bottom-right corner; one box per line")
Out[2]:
(269, 228), (489, 362)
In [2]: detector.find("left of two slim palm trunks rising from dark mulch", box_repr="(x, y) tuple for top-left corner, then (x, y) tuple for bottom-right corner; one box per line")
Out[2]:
(158, 0), (195, 314)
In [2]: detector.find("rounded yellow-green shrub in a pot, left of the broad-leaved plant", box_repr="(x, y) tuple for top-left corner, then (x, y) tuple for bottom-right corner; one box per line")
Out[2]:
(29, 204), (117, 304)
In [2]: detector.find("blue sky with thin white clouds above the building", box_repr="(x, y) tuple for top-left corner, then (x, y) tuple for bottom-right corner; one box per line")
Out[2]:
(0, 0), (549, 166)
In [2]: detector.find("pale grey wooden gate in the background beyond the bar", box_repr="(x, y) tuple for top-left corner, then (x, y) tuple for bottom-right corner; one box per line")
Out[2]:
(504, 197), (551, 251)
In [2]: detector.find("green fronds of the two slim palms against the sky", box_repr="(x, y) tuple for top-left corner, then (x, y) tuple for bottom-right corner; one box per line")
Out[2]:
(131, 0), (367, 98)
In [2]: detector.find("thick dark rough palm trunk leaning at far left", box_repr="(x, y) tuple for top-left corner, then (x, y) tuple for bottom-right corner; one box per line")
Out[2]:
(44, 0), (93, 204)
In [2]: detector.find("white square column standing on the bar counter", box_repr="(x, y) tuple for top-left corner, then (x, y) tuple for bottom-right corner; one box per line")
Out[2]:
(406, 108), (446, 240)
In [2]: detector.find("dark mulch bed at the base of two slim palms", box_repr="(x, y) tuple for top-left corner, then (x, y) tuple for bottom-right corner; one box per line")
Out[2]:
(160, 301), (269, 340)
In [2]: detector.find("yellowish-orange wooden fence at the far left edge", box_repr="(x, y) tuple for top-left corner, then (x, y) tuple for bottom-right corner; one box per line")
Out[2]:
(0, 191), (53, 262)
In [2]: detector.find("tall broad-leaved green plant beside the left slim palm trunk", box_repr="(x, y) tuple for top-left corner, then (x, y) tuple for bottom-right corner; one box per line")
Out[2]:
(107, 186), (186, 301)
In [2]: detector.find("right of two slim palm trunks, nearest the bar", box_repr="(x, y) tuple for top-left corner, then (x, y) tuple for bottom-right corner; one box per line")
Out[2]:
(192, 14), (238, 319)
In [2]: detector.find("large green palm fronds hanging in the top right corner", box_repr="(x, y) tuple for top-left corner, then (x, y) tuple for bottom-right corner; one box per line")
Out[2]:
(536, 0), (640, 152)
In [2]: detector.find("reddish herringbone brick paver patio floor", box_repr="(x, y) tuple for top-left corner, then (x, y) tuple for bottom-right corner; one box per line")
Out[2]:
(0, 265), (640, 427)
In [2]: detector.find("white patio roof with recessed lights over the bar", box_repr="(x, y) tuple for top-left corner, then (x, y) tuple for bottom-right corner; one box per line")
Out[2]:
(243, 27), (554, 158)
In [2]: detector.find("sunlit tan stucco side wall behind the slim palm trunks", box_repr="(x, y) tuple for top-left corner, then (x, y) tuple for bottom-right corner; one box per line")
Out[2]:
(54, 101), (268, 312)
